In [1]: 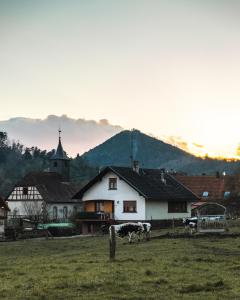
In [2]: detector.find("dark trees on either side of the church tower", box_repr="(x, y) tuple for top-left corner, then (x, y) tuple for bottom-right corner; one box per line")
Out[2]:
(0, 132), (98, 197)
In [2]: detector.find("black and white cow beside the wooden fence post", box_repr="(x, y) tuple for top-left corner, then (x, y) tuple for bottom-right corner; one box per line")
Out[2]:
(112, 222), (151, 243)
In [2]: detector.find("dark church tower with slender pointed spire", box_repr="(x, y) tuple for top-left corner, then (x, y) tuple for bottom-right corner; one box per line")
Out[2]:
(50, 129), (70, 182)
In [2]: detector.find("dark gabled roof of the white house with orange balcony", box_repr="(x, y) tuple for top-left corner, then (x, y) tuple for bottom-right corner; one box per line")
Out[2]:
(74, 166), (199, 202)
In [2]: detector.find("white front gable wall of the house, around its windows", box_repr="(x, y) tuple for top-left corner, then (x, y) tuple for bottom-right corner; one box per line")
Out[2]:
(82, 172), (145, 221)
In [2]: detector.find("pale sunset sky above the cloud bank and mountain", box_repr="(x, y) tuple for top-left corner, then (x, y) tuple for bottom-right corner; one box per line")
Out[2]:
(0, 0), (240, 157)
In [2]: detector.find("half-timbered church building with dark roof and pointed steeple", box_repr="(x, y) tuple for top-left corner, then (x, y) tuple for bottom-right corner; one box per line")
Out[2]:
(7, 132), (79, 220)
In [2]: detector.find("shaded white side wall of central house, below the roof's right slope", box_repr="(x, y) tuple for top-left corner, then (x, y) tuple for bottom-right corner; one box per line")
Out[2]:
(146, 200), (191, 220)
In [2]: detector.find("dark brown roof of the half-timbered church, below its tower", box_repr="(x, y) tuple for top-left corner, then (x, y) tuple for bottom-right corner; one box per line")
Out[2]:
(16, 172), (77, 203)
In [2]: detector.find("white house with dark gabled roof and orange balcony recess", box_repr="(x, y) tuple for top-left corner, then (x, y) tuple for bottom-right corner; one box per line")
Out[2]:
(73, 165), (199, 231)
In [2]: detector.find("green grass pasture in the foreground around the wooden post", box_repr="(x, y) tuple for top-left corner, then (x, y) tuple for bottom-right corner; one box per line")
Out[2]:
(0, 232), (240, 300)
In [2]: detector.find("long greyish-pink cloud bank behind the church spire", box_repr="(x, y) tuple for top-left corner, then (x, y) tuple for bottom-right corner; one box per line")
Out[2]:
(0, 115), (123, 157)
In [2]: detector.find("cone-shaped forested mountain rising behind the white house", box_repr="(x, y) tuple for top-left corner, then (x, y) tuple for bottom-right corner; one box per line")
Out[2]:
(82, 130), (240, 174)
